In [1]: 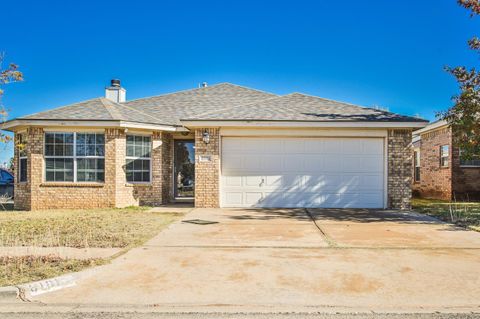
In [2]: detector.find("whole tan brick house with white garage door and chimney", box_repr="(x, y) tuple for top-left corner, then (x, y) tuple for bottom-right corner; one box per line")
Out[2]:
(4, 80), (426, 209)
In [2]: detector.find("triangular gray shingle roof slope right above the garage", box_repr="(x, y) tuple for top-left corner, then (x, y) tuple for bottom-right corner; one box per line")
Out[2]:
(182, 93), (424, 122)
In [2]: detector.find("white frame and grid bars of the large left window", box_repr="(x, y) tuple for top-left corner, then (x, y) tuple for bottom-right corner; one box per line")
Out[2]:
(43, 131), (106, 184)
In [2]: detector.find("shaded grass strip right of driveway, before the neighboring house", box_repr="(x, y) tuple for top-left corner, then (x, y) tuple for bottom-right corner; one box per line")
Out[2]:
(412, 198), (480, 227)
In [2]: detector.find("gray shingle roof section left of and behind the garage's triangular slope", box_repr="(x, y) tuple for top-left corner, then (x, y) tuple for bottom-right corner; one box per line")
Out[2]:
(19, 83), (276, 125)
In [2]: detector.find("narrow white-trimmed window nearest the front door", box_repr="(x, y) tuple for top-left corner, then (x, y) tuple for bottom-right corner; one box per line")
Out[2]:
(125, 135), (152, 183)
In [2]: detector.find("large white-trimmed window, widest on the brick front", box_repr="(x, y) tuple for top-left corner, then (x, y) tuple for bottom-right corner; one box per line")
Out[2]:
(45, 132), (105, 182)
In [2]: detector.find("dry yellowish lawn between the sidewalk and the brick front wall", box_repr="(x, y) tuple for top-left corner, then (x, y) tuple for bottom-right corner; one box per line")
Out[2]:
(0, 207), (182, 248)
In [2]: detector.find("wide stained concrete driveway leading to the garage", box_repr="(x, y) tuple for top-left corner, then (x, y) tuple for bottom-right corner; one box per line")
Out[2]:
(33, 209), (480, 312)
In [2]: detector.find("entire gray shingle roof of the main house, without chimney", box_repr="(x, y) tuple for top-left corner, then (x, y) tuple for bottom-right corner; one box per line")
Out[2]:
(8, 83), (426, 126)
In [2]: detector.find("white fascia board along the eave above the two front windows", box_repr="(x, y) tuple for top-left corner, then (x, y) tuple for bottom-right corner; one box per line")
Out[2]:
(0, 119), (179, 132)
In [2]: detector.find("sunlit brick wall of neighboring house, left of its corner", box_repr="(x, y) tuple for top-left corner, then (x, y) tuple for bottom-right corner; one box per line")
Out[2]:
(412, 127), (452, 200)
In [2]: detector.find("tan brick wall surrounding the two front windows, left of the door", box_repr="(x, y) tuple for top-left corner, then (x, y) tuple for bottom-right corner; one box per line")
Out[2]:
(15, 128), (172, 210)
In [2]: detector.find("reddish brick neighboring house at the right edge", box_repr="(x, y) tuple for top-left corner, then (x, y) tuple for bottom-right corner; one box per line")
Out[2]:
(412, 121), (480, 200)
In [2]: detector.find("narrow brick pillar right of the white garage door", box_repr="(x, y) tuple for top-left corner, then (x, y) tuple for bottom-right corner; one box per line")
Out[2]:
(388, 129), (412, 209)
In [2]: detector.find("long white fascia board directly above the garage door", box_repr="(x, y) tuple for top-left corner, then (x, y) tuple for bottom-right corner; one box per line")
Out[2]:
(181, 121), (428, 128)
